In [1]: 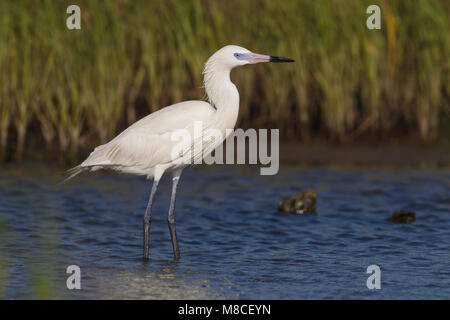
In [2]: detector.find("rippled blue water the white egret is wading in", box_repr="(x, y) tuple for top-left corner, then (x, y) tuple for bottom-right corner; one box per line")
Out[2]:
(0, 164), (450, 299)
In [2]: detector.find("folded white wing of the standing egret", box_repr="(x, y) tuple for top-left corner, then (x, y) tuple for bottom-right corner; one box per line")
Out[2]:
(81, 101), (215, 170)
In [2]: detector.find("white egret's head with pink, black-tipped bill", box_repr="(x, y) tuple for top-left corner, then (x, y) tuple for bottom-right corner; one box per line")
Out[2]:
(206, 45), (294, 70)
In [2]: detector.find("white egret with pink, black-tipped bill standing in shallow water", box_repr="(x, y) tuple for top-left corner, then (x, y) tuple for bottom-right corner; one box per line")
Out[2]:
(66, 45), (294, 259)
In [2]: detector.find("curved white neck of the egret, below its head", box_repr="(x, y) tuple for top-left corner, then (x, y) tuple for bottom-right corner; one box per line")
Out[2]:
(203, 64), (239, 129)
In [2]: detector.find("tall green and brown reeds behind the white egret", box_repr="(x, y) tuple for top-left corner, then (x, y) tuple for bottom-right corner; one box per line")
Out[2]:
(0, 0), (450, 160)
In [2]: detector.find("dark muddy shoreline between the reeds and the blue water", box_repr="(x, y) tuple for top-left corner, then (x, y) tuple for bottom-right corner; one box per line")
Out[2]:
(0, 140), (450, 168)
